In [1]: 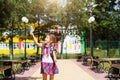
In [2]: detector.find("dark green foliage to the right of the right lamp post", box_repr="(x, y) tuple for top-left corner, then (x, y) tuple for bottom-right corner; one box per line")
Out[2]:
(93, 0), (120, 41)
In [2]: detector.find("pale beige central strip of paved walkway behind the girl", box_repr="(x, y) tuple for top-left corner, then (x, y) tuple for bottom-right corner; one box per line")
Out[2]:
(31, 60), (95, 80)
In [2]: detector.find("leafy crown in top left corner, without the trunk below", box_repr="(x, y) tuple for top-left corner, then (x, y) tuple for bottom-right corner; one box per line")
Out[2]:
(0, 0), (31, 27)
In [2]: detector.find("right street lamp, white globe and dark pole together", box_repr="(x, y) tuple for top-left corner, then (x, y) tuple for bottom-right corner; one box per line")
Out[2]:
(88, 16), (95, 57)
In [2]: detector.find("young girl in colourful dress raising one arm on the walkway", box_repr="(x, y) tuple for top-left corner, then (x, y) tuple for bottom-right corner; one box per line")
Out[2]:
(30, 31), (58, 80)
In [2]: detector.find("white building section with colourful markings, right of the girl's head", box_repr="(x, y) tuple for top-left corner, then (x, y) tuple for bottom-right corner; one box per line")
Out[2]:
(58, 35), (85, 54)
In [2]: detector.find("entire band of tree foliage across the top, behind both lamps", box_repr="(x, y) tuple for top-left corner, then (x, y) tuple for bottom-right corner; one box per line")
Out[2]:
(0, 0), (120, 59)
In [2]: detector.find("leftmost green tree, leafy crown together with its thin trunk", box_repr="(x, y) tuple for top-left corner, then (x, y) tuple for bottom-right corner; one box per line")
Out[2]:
(0, 0), (31, 59)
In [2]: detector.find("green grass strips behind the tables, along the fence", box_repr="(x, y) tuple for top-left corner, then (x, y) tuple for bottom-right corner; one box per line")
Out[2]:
(0, 48), (120, 60)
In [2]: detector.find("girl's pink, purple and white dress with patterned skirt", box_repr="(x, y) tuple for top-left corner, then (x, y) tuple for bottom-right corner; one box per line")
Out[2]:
(41, 45), (59, 75)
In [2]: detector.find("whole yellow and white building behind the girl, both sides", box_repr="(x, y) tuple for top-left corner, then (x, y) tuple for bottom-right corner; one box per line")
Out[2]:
(0, 35), (85, 54)
